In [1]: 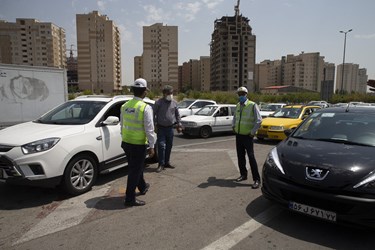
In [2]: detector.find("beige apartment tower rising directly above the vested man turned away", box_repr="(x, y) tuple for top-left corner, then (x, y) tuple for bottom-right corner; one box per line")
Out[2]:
(142, 23), (178, 91)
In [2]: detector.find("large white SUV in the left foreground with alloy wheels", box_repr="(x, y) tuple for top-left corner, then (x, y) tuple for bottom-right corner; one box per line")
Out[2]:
(0, 96), (154, 195)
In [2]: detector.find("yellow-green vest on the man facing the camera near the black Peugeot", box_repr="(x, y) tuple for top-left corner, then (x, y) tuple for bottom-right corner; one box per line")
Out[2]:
(234, 101), (255, 135)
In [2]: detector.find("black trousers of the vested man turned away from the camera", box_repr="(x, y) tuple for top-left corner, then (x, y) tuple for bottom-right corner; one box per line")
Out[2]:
(121, 142), (147, 202)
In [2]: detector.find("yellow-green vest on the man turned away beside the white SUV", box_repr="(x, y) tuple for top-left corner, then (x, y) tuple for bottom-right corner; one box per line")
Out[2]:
(121, 99), (147, 145)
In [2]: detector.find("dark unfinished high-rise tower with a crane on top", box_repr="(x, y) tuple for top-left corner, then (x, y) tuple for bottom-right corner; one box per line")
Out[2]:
(210, 0), (257, 92)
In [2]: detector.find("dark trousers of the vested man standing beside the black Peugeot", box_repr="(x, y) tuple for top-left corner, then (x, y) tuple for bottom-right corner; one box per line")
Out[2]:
(236, 134), (260, 181)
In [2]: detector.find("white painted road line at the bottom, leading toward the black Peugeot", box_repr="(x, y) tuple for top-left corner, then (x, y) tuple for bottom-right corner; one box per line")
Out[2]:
(202, 206), (281, 250)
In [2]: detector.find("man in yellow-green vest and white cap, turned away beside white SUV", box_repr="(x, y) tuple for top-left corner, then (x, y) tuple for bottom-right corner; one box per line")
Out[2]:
(121, 78), (156, 206)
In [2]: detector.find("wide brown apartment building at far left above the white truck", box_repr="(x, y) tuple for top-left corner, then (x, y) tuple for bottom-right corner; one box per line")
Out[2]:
(0, 18), (66, 68)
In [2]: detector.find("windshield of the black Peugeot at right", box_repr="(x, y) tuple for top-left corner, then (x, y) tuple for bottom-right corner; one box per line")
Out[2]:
(292, 112), (375, 146)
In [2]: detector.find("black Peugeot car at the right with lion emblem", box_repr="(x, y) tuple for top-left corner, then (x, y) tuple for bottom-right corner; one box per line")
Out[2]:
(262, 106), (375, 227)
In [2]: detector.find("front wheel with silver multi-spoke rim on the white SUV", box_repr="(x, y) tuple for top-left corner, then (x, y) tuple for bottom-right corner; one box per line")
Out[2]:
(63, 154), (98, 195)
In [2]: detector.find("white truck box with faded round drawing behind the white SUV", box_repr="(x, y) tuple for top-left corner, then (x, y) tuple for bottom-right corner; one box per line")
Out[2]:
(0, 64), (68, 128)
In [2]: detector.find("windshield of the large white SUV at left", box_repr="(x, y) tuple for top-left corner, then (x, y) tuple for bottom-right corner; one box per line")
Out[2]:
(34, 101), (107, 125)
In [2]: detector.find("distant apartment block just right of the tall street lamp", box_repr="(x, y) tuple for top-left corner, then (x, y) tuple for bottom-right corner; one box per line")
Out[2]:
(336, 63), (368, 93)
